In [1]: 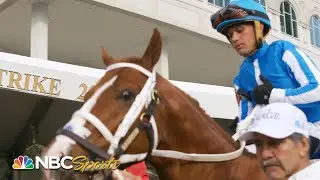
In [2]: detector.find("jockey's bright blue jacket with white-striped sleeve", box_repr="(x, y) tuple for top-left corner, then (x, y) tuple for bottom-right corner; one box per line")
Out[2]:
(234, 40), (320, 123)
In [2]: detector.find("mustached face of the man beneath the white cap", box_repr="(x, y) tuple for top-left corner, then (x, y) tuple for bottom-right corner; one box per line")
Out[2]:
(254, 133), (309, 180)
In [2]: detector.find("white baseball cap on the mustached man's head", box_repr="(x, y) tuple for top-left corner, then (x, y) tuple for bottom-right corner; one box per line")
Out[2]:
(239, 103), (309, 141)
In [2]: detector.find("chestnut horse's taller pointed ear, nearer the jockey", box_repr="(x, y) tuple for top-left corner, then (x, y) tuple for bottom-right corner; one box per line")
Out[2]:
(142, 29), (162, 71)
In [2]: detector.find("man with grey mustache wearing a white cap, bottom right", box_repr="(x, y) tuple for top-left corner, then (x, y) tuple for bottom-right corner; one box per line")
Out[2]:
(239, 103), (320, 180)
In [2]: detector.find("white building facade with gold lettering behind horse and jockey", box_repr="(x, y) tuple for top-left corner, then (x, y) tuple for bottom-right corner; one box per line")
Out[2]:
(0, 0), (320, 177)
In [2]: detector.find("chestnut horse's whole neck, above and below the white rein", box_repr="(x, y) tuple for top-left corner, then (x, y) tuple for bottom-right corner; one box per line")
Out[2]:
(152, 78), (262, 179)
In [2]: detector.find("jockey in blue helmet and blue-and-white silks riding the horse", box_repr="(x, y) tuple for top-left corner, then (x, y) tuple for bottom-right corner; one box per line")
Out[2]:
(211, 0), (320, 157)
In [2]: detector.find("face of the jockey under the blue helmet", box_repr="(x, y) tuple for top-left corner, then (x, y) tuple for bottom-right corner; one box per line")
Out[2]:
(226, 23), (256, 57)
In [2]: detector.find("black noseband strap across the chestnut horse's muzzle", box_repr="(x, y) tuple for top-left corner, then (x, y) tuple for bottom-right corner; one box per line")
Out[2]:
(57, 129), (110, 160)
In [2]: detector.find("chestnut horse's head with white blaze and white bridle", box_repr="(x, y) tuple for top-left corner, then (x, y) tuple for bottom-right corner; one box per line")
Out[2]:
(43, 29), (162, 179)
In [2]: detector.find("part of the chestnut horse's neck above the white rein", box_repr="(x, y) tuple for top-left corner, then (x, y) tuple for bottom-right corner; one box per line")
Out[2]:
(157, 76), (236, 158)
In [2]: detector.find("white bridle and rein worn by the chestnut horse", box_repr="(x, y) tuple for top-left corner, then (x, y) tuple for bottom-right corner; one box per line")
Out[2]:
(48, 63), (245, 178)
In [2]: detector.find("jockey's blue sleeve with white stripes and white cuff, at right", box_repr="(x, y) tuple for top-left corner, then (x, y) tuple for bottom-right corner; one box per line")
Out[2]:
(269, 48), (320, 106)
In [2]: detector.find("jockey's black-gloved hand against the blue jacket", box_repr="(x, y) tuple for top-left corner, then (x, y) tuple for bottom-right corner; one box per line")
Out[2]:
(253, 75), (273, 105)
